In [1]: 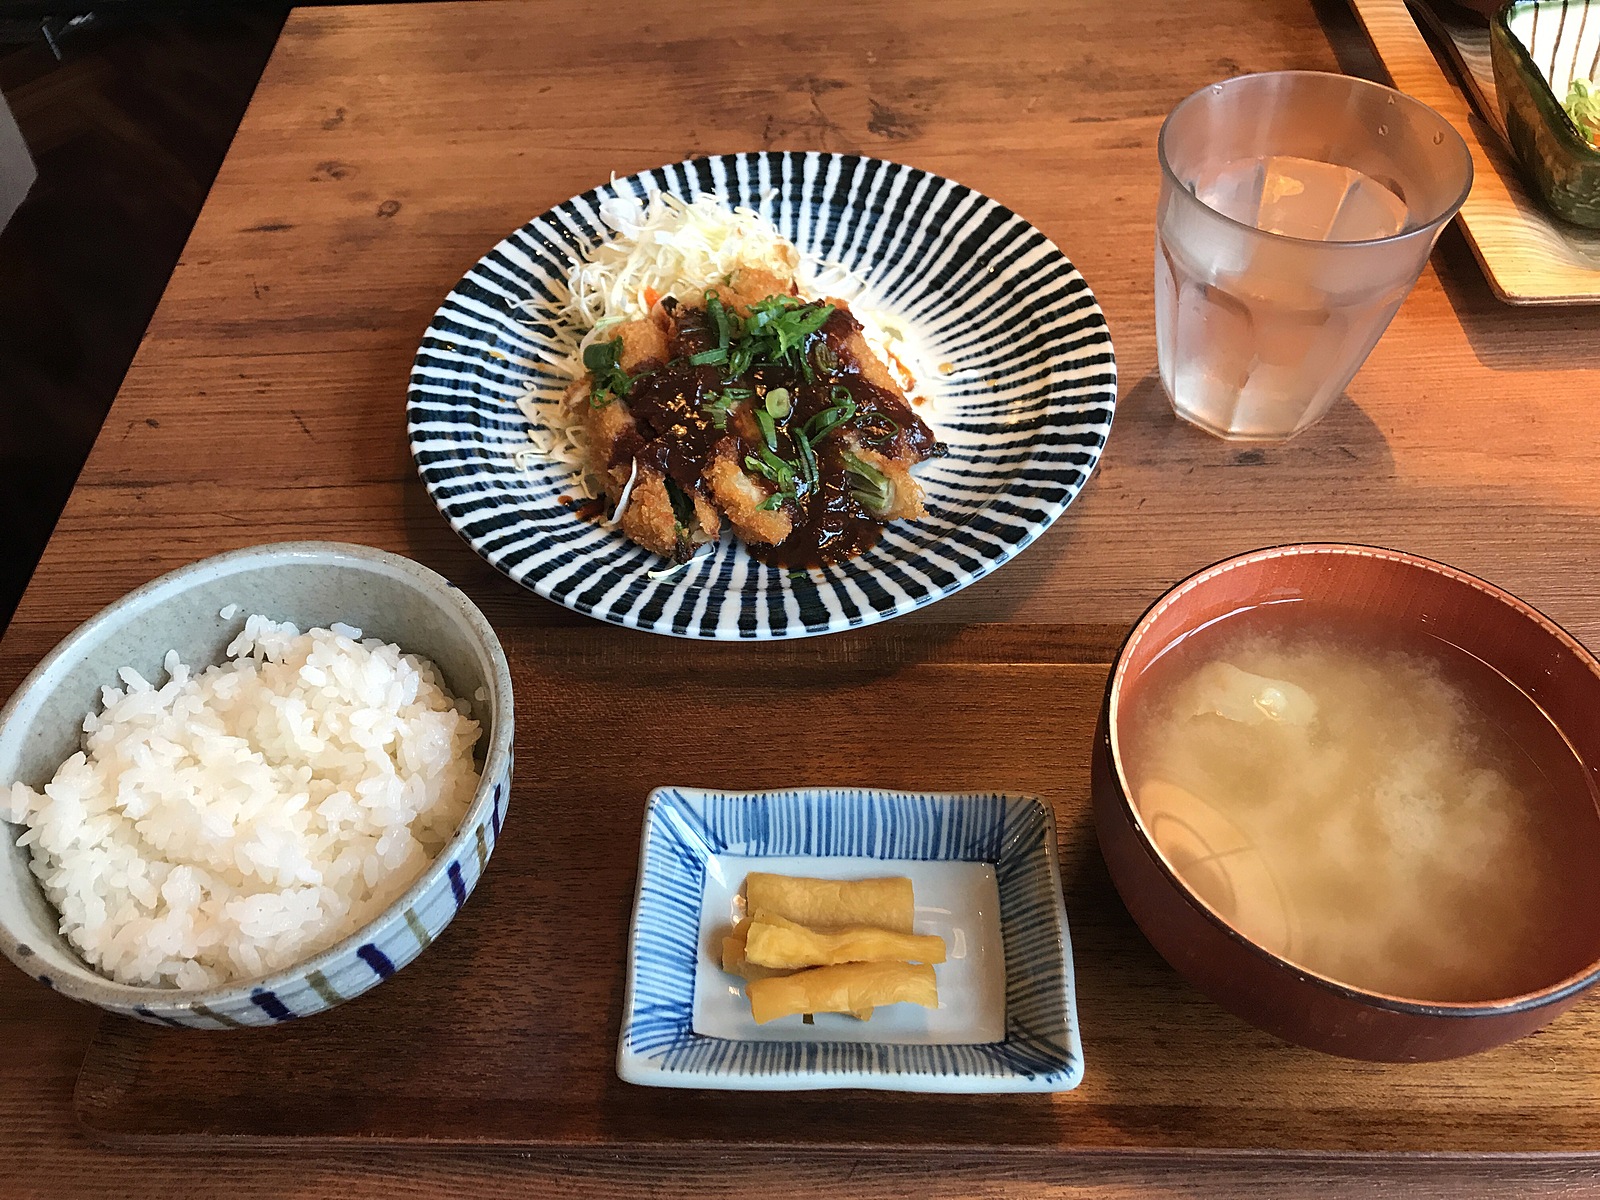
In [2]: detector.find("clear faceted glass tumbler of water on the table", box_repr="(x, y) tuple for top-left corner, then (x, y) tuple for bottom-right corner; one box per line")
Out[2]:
(1155, 70), (1472, 442)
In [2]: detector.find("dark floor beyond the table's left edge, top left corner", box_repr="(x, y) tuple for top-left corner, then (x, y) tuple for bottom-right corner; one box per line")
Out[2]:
(0, 5), (288, 630)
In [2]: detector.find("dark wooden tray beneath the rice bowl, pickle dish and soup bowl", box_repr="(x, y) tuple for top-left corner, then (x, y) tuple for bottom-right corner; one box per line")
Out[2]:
(77, 622), (1600, 1154)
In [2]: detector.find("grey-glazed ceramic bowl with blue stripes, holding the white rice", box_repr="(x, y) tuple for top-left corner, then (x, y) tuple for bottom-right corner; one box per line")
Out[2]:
(0, 542), (512, 1027)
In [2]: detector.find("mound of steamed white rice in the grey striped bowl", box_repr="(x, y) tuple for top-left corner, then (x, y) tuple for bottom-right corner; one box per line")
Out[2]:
(0, 616), (478, 987)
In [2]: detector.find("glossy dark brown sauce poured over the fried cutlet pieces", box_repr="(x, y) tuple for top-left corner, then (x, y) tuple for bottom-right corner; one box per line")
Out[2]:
(611, 306), (944, 568)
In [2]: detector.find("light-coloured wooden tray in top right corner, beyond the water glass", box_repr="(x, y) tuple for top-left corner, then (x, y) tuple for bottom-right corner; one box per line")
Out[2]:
(1350, 0), (1600, 304)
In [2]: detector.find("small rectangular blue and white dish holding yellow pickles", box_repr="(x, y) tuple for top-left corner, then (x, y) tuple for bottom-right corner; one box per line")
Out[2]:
(616, 787), (1083, 1093)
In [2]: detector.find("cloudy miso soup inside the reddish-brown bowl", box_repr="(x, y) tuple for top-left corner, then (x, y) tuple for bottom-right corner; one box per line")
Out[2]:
(1120, 602), (1600, 1002)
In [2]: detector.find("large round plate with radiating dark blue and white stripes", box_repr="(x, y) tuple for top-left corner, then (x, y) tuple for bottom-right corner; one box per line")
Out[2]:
(406, 152), (1117, 638)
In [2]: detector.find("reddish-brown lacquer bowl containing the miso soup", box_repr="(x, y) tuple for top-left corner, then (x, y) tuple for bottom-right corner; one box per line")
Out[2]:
(1093, 544), (1600, 1061)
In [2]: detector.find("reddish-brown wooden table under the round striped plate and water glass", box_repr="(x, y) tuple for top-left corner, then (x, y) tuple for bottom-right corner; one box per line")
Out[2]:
(9, 0), (1600, 1197)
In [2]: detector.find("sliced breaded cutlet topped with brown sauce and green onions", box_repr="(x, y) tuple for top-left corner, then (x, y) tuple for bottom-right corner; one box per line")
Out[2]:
(566, 269), (944, 566)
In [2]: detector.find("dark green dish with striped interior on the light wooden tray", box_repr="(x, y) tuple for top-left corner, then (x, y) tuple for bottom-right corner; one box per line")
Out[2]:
(1490, 0), (1600, 229)
